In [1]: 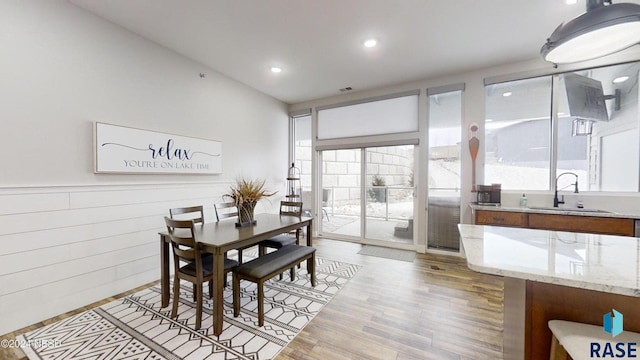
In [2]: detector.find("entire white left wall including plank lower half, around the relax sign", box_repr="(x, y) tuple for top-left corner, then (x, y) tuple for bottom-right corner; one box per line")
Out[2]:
(0, 0), (288, 334)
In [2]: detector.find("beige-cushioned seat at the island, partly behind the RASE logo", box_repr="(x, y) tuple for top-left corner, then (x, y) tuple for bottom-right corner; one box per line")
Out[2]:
(549, 320), (640, 360)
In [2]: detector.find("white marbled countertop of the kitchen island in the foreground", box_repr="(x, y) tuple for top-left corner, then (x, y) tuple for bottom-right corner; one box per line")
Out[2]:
(458, 224), (640, 297)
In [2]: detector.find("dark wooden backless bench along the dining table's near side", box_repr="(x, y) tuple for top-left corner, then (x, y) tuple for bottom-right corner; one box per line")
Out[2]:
(233, 245), (316, 326)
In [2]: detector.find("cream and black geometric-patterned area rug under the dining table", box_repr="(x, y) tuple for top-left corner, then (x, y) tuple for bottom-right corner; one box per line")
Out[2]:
(19, 257), (359, 360)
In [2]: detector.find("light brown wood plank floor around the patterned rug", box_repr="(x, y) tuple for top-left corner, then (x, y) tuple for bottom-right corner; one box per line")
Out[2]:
(0, 239), (503, 360)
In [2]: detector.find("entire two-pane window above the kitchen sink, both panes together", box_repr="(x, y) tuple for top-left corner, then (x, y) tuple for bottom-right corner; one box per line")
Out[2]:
(484, 62), (640, 192)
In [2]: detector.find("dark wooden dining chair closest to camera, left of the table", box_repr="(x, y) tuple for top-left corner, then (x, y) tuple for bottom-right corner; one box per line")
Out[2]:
(164, 216), (238, 330)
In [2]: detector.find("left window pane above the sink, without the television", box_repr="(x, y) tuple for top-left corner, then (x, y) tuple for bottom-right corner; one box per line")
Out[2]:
(484, 76), (551, 190)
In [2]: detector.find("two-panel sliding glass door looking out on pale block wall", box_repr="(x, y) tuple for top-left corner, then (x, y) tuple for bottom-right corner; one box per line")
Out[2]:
(321, 145), (415, 245)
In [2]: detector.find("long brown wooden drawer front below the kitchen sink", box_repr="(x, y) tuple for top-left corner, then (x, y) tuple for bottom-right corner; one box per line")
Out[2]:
(529, 214), (634, 236)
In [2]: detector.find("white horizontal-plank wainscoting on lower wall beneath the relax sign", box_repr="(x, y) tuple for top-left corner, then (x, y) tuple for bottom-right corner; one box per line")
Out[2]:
(0, 183), (228, 334)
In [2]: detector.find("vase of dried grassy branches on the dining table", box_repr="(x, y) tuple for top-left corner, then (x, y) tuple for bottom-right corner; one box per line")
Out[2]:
(222, 178), (277, 227)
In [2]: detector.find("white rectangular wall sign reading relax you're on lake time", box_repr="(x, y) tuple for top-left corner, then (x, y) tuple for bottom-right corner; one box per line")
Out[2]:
(94, 123), (222, 174)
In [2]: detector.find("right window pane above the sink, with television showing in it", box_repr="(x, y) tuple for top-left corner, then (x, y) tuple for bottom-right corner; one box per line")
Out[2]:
(556, 63), (640, 191)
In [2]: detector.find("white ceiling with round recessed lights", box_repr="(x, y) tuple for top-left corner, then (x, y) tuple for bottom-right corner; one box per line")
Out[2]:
(69, 0), (632, 104)
